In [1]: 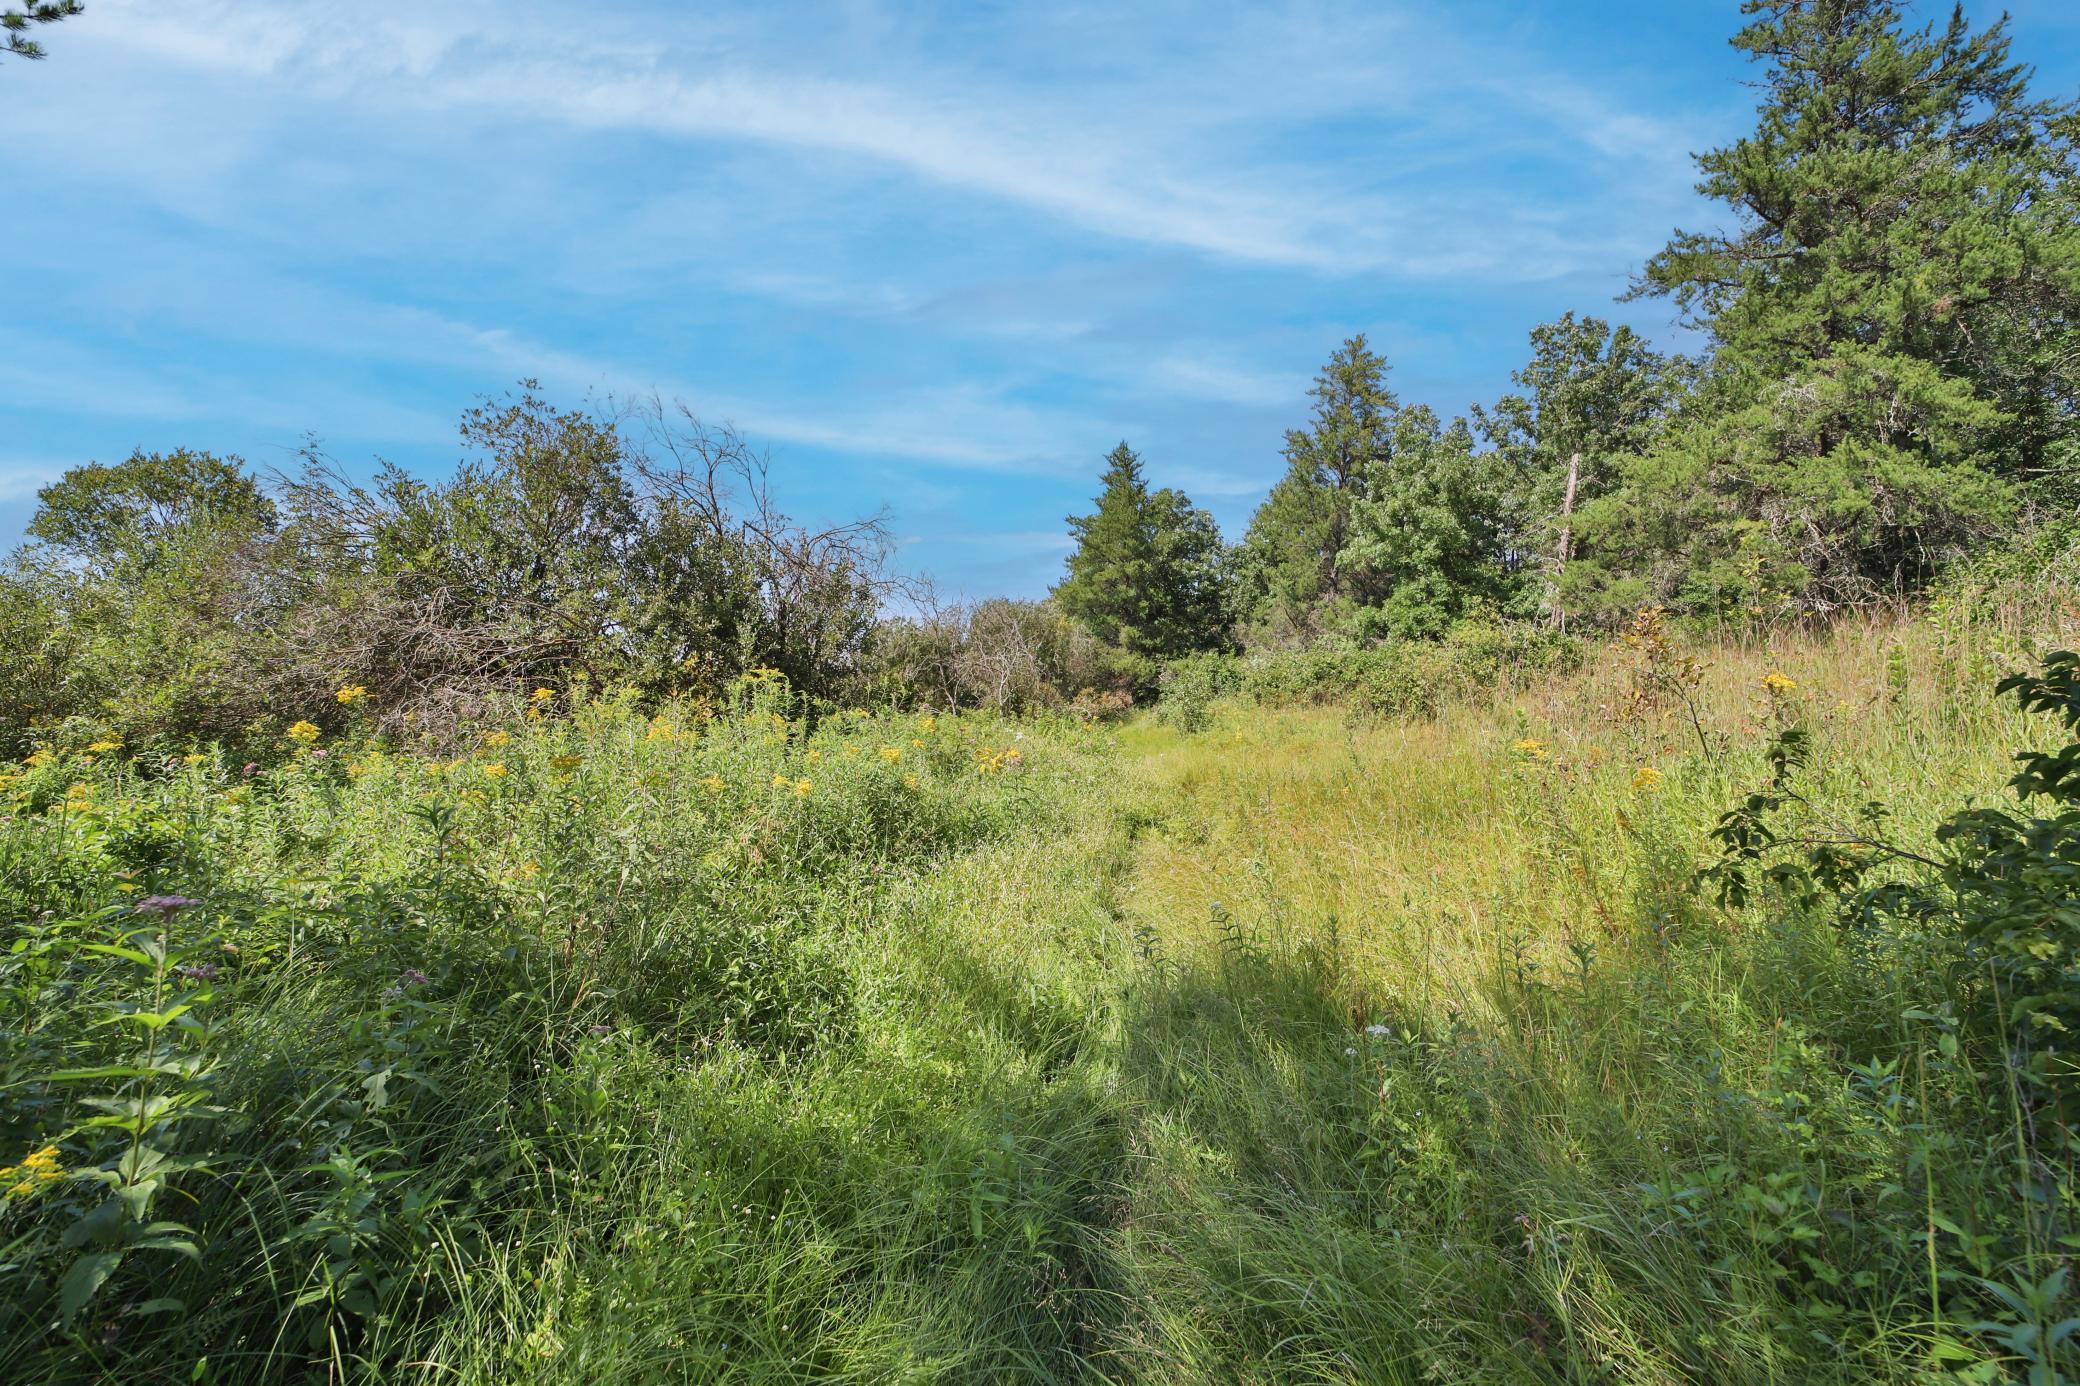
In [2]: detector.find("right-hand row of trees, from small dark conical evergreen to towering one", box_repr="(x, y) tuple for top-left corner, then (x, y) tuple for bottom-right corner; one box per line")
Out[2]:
(998, 0), (2080, 660)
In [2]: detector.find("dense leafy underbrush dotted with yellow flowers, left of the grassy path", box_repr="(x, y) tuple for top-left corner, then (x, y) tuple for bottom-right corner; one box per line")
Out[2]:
(0, 676), (1084, 1380)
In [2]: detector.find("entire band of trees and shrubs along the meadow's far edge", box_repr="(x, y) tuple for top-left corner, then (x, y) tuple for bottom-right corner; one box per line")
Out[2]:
(0, 0), (2080, 753)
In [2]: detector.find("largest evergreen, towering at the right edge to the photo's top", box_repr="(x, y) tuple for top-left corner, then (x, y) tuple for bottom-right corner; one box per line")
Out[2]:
(1614, 0), (2080, 608)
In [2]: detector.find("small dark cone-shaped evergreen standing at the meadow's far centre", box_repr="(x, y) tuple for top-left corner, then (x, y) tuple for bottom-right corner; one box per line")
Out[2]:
(1055, 443), (1231, 658)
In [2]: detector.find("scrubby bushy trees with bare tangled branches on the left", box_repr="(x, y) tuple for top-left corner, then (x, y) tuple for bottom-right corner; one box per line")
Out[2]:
(0, 391), (892, 747)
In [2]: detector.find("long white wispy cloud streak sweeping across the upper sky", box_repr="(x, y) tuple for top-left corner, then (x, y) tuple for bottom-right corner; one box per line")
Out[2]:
(73, 0), (1705, 278)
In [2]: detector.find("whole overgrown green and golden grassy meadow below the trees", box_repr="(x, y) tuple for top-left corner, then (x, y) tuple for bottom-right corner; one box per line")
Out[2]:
(0, 626), (2074, 1382)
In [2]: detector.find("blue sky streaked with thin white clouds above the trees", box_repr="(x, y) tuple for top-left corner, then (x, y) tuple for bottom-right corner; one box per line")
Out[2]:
(0, 0), (2080, 595)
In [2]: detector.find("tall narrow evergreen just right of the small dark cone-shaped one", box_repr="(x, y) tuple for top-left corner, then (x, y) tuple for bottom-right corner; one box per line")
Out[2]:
(1240, 333), (1400, 628)
